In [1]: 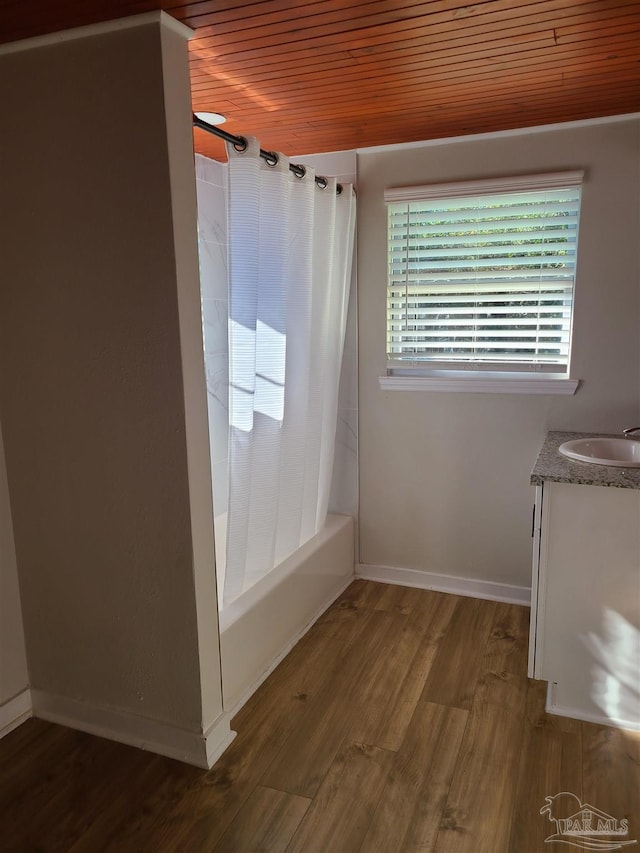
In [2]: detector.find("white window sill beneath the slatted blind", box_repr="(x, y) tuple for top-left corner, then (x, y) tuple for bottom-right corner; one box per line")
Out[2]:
(378, 370), (580, 395)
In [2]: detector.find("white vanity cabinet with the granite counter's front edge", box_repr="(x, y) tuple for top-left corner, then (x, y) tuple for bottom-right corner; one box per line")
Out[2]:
(529, 433), (640, 729)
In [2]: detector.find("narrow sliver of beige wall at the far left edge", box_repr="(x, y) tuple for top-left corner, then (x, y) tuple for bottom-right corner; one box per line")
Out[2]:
(0, 420), (29, 706)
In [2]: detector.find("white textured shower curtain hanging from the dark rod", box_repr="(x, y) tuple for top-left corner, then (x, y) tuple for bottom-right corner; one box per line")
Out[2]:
(224, 138), (355, 604)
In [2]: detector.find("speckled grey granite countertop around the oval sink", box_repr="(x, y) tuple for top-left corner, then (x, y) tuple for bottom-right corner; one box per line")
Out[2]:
(531, 432), (640, 489)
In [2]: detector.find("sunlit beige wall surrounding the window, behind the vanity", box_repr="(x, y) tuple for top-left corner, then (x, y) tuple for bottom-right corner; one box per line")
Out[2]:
(358, 120), (640, 586)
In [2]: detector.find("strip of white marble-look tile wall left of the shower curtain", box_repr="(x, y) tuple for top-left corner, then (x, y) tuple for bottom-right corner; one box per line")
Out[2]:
(196, 155), (229, 516)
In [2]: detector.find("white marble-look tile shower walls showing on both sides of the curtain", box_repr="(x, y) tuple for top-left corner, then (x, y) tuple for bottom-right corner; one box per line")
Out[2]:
(196, 151), (358, 540)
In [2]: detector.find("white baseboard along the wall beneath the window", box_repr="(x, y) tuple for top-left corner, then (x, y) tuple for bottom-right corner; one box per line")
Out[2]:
(356, 563), (531, 607)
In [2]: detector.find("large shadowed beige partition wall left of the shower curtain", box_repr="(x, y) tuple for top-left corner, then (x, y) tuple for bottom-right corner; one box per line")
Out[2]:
(0, 16), (221, 744)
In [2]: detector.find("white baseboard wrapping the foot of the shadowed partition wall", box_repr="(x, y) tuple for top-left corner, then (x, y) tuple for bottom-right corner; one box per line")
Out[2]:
(31, 690), (235, 770)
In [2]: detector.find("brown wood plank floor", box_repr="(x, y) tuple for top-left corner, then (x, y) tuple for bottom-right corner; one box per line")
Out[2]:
(0, 581), (640, 853)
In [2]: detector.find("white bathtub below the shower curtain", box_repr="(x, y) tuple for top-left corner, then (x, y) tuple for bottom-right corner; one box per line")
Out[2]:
(216, 515), (354, 715)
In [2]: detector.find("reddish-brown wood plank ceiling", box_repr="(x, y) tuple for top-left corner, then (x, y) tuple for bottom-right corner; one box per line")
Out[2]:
(0, 0), (640, 159)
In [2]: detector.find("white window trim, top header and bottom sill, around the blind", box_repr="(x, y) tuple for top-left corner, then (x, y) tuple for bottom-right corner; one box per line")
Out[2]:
(378, 169), (584, 395)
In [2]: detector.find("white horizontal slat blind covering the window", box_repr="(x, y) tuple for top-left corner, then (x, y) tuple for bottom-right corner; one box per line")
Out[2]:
(385, 172), (582, 373)
